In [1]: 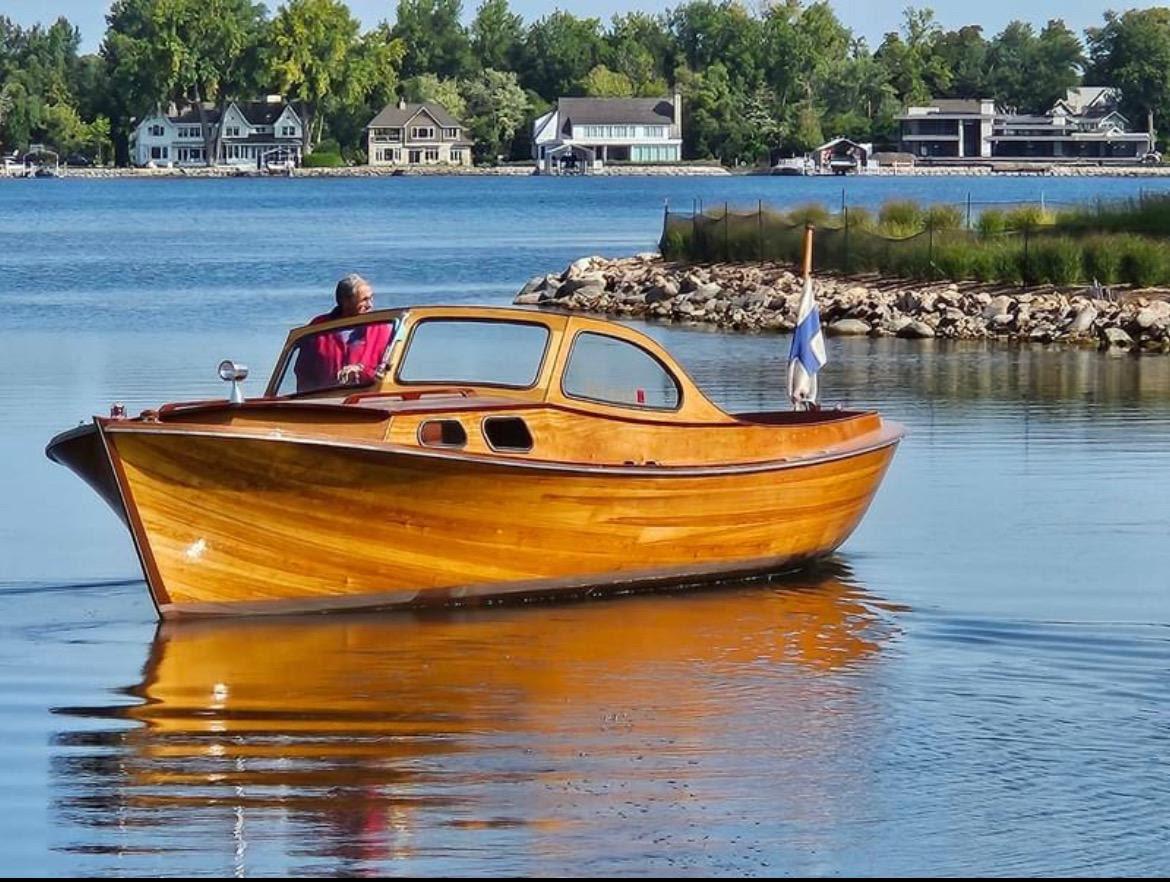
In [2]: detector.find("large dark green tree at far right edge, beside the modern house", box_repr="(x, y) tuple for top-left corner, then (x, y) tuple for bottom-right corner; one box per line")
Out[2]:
(1087, 6), (1170, 144)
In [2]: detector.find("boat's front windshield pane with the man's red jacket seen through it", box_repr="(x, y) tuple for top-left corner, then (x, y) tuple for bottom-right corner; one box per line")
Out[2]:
(276, 321), (398, 395)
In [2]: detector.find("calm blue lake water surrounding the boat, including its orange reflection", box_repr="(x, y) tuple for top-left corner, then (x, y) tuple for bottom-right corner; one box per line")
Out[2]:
(0, 178), (1170, 876)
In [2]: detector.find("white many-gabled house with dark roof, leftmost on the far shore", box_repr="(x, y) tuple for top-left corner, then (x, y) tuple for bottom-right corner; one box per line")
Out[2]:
(130, 96), (304, 168)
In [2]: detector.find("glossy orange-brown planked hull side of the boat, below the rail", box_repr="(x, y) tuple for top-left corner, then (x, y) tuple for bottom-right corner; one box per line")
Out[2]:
(91, 423), (897, 616)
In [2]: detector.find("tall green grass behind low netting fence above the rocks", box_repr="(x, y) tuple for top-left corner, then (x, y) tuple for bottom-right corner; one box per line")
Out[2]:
(660, 197), (1170, 287)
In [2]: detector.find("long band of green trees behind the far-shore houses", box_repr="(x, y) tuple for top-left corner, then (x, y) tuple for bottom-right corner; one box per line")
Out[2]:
(0, 0), (1170, 165)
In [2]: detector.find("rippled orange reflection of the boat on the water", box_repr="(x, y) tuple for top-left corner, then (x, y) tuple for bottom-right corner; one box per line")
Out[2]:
(55, 566), (896, 873)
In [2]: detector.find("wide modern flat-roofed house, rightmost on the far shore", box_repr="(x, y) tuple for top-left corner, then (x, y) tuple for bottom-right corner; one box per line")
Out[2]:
(899, 87), (1152, 163)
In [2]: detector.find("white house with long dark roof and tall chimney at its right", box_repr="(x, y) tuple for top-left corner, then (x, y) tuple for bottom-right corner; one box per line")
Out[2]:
(532, 92), (682, 172)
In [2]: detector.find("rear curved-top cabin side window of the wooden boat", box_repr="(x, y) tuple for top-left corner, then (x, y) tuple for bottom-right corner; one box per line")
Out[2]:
(560, 332), (682, 411)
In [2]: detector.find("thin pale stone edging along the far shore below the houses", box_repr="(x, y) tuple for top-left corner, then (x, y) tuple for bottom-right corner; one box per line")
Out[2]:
(11, 164), (1170, 181)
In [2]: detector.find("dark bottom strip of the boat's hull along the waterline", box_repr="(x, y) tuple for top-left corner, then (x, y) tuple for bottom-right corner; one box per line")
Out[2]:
(159, 551), (831, 619)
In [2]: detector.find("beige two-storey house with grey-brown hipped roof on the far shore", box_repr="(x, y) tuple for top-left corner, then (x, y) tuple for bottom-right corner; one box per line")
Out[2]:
(366, 101), (474, 166)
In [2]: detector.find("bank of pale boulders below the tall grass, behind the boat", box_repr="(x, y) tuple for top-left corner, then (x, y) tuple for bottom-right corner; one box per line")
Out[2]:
(515, 253), (1170, 352)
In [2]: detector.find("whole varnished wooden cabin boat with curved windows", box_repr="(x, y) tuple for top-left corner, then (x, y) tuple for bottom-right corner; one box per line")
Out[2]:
(47, 306), (902, 616)
